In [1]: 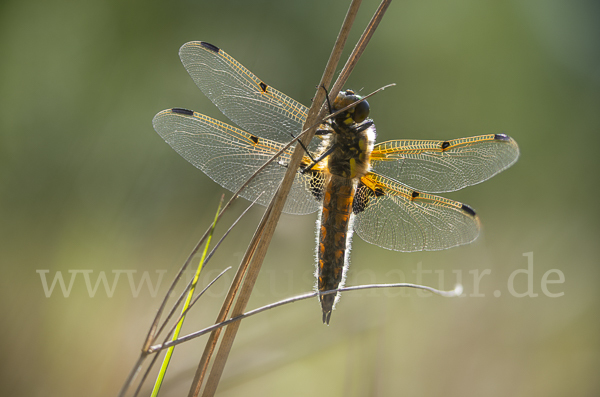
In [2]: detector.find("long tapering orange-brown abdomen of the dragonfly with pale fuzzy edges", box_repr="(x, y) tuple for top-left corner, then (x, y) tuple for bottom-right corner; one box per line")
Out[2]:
(317, 175), (356, 324)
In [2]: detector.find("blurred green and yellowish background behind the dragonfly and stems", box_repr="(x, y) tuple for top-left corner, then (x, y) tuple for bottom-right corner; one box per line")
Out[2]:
(0, 0), (600, 396)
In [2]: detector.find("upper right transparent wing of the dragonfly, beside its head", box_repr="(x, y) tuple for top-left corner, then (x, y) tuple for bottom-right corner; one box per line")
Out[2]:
(371, 134), (519, 193)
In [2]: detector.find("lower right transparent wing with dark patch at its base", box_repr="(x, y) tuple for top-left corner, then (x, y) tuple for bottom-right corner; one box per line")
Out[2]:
(353, 173), (480, 252)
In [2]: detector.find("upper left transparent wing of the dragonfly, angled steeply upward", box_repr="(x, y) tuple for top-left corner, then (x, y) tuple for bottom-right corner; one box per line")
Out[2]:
(179, 41), (318, 149)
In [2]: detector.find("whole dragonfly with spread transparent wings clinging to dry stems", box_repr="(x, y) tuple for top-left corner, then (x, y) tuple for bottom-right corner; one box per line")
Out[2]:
(152, 41), (519, 324)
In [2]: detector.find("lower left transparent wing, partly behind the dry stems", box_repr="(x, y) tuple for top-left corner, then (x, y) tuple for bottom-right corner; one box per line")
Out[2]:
(152, 109), (320, 214)
